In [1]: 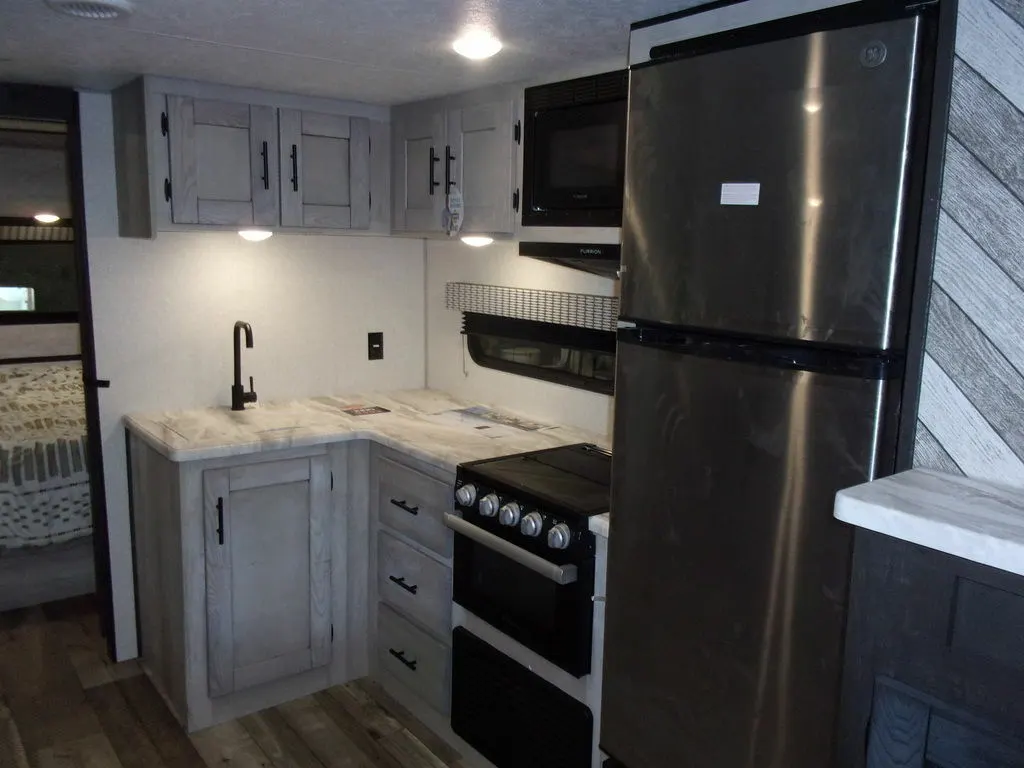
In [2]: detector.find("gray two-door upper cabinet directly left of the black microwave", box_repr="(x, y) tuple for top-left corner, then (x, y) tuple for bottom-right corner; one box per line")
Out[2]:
(391, 87), (519, 234)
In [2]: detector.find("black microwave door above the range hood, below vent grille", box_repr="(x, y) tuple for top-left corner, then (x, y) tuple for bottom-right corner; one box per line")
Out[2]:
(530, 101), (626, 210)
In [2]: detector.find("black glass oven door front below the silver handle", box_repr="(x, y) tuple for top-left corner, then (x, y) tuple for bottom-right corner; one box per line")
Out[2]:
(454, 535), (594, 677)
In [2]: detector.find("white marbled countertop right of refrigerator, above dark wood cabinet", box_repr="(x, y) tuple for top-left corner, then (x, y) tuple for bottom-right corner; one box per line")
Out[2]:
(836, 469), (1024, 575)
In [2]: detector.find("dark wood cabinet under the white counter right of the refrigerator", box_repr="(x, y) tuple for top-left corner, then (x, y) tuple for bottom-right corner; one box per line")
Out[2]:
(838, 529), (1024, 768)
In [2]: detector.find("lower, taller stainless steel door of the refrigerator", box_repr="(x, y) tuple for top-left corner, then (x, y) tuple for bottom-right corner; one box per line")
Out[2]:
(601, 344), (898, 768)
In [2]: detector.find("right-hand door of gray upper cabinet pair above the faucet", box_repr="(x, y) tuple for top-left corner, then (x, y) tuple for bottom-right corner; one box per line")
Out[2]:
(280, 110), (370, 229)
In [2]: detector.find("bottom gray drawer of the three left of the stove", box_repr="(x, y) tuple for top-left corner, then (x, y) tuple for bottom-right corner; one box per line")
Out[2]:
(377, 604), (452, 714)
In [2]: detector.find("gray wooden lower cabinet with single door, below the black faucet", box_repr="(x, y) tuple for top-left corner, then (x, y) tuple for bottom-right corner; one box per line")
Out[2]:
(129, 436), (352, 731)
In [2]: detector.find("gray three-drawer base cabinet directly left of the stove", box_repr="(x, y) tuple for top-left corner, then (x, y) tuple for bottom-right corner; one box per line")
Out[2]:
(370, 449), (455, 719)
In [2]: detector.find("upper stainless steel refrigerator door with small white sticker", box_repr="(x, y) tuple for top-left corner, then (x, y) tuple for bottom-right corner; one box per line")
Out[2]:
(622, 17), (920, 349)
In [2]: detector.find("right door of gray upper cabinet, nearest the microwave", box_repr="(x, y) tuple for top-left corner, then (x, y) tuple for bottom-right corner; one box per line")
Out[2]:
(442, 99), (515, 233)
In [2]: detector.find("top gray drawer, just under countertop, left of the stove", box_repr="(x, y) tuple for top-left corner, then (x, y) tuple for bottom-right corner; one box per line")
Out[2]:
(377, 458), (454, 557)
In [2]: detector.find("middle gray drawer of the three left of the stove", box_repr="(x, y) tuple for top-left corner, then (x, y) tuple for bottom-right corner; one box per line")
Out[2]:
(377, 530), (452, 636)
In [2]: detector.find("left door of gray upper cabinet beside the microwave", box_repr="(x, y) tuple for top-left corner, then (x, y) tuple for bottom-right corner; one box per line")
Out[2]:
(391, 102), (444, 232)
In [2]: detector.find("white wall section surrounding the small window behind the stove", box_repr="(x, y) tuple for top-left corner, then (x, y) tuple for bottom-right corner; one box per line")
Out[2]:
(427, 241), (617, 434)
